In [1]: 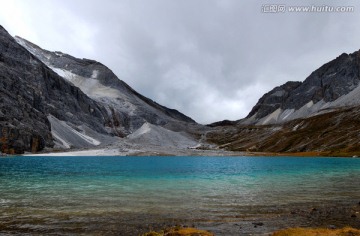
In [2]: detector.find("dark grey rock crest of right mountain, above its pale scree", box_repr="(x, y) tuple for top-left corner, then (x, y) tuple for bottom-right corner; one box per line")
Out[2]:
(246, 51), (360, 120)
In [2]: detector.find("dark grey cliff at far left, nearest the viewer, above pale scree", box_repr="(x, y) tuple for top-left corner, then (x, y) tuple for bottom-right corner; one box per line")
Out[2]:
(0, 26), (108, 153)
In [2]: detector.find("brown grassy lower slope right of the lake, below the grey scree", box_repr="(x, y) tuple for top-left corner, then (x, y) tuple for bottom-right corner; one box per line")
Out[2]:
(207, 106), (360, 156)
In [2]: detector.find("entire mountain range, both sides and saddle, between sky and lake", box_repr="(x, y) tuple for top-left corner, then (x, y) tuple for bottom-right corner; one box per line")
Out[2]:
(0, 21), (360, 155)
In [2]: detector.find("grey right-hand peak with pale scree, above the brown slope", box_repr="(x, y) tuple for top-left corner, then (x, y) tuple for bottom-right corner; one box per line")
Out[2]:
(240, 51), (360, 125)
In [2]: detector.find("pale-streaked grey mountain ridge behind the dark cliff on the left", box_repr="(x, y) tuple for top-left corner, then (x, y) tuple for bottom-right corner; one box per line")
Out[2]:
(16, 37), (195, 137)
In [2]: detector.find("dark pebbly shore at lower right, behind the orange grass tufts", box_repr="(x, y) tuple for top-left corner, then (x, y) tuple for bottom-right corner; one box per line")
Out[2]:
(140, 201), (360, 236)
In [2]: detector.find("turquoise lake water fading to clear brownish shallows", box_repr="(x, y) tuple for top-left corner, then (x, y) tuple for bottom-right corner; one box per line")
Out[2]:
(0, 157), (360, 235)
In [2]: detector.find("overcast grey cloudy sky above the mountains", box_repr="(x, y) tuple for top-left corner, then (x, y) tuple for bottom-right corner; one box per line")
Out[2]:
(0, 0), (360, 123)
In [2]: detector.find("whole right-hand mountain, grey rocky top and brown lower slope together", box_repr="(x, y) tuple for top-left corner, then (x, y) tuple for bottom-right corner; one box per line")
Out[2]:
(210, 51), (360, 156)
